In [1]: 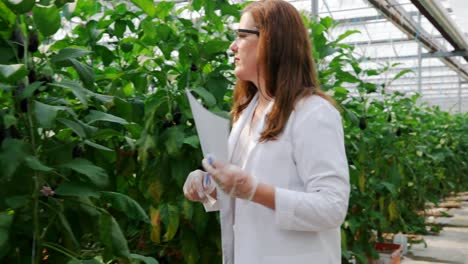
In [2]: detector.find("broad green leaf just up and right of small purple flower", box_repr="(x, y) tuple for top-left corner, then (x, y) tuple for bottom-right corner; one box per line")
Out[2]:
(62, 158), (107, 187)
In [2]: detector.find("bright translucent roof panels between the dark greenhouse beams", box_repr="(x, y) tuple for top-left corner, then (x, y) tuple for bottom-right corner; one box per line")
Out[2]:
(289, 0), (468, 112)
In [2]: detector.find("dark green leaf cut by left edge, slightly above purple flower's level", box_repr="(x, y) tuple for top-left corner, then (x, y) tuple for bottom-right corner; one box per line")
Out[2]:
(0, 138), (27, 179)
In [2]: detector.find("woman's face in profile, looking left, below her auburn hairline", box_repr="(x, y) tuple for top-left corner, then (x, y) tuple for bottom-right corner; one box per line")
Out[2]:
(230, 13), (258, 84)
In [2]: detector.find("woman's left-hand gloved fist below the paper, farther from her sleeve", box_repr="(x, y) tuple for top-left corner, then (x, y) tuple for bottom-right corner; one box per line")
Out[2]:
(183, 170), (216, 203)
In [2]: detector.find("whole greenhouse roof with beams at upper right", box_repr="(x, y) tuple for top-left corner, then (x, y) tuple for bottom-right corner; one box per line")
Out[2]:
(289, 0), (468, 112)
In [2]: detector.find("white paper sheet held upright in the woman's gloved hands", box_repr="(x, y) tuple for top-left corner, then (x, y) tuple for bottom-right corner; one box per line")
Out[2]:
(185, 90), (229, 212)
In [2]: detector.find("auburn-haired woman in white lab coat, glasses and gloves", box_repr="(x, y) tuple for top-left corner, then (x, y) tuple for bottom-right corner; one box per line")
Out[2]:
(184, 0), (349, 264)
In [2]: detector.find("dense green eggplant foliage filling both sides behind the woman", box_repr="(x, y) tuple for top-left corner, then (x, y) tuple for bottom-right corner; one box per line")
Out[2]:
(0, 0), (468, 263)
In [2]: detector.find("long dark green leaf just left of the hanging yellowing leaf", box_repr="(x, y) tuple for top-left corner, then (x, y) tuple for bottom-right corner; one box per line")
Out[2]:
(101, 192), (150, 223)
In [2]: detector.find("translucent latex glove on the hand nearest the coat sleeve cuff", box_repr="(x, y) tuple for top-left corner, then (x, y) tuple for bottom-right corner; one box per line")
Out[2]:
(202, 158), (258, 201)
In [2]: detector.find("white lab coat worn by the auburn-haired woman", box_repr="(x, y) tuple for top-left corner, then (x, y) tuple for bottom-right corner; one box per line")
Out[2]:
(203, 95), (350, 264)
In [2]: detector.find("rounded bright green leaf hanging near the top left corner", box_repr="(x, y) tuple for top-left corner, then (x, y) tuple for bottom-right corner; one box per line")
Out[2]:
(33, 5), (61, 36)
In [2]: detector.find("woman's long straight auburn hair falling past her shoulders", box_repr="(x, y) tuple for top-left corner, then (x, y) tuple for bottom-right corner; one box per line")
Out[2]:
(231, 0), (335, 142)
